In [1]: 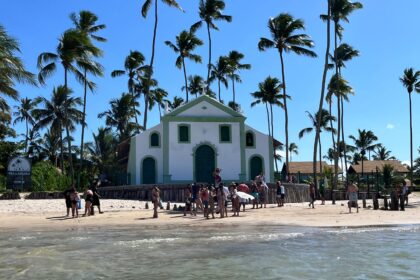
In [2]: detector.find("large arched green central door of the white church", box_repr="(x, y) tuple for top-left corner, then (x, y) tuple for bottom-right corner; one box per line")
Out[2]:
(195, 145), (216, 183)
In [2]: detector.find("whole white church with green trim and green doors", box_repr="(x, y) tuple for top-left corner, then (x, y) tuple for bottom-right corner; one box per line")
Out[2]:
(127, 95), (274, 185)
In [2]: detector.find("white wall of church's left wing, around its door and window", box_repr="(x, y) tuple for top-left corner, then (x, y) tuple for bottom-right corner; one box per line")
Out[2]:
(135, 124), (163, 184)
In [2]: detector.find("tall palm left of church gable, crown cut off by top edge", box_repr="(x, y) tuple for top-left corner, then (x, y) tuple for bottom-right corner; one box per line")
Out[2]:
(141, 0), (183, 129)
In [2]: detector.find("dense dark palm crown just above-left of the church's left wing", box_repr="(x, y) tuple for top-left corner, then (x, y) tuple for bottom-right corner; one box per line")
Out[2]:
(98, 93), (138, 142)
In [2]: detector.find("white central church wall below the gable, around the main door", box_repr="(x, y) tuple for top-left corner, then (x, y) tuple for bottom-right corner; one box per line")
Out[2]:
(169, 121), (241, 181)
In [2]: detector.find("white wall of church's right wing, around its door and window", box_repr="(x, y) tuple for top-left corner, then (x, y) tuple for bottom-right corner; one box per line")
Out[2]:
(245, 125), (273, 181)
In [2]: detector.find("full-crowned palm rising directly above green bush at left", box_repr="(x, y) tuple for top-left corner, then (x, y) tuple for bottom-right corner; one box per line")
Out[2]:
(32, 86), (83, 178)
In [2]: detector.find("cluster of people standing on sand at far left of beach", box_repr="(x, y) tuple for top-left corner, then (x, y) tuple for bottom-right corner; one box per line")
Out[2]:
(63, 181), (103, 218)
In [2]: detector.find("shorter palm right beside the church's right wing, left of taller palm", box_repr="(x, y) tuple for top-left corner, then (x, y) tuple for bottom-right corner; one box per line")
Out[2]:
(251, 76), (284, 171)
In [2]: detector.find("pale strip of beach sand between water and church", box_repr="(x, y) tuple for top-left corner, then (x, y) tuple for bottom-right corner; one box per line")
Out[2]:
(0, 193), (420, 230)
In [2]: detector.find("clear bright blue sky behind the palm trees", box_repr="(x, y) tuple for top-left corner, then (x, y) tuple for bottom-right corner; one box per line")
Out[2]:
(0, 0), (420, 164)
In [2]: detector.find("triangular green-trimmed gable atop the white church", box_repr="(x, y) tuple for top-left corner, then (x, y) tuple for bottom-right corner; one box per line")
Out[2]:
(167, 95), (243, 117)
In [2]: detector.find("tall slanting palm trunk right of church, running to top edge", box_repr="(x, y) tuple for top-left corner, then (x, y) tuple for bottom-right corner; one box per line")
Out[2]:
(312, 0), (334, 189)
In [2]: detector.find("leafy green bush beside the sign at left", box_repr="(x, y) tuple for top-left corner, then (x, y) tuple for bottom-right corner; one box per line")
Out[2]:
(32, 161), (70, 191)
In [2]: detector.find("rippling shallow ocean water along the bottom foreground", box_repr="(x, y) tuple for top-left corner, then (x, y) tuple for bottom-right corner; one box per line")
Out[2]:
(0, 226), (420, 280)
